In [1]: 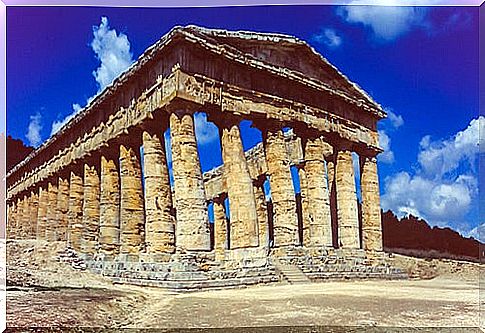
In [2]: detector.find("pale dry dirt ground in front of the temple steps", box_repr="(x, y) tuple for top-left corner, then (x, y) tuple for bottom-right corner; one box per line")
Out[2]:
(7, 237), (480, 328)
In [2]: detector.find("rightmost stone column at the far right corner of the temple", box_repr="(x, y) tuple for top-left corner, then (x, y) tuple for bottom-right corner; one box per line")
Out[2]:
(360, 155), (382, 251)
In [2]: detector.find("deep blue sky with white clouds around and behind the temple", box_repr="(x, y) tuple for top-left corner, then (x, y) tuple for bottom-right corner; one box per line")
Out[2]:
(7, 6), (485, 236)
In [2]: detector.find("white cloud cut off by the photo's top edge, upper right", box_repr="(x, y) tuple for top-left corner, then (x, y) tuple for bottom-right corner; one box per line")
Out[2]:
(337, 0), (428, 41)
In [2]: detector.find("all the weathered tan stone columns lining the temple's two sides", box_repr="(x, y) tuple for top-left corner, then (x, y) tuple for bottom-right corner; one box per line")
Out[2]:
(5, 111), (382, 255)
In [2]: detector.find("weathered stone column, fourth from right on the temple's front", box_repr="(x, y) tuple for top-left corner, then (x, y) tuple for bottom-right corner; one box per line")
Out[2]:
(263, 129), (298, 246)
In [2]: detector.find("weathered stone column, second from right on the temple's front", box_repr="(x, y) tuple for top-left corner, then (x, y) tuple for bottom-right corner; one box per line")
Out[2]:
(335, 148), (360, 249)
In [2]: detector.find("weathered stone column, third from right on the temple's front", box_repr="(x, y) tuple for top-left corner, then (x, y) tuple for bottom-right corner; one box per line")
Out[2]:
(304, 137), (332, 246)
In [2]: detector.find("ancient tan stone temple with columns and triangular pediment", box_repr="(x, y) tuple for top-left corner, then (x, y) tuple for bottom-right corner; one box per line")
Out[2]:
(7, 26), (403, 289)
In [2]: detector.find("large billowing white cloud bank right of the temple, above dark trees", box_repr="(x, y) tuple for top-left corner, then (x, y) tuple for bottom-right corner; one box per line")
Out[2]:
(381, 116), (485, 235)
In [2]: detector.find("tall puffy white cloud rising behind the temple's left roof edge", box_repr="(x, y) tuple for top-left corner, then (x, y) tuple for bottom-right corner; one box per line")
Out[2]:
(51, 17), (133, 136)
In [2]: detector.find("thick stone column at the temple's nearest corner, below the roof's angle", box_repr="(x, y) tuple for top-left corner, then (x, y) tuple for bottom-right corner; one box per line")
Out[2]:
(170, 113), (210, 251)
